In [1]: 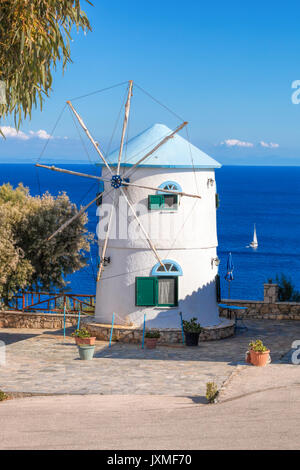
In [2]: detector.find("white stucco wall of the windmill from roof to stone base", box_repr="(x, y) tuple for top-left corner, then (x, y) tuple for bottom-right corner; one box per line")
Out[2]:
(95, 168), (220, 328)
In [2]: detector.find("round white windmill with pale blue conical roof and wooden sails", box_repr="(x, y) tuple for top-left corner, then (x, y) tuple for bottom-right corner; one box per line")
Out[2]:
(37, 81), (221, 328)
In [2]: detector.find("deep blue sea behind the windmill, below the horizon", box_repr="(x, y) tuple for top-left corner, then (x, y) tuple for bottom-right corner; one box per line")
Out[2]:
(0, 164), (300, 299)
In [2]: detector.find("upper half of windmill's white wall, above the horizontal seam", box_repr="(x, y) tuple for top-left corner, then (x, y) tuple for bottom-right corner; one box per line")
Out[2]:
(100, 168), (217, 249)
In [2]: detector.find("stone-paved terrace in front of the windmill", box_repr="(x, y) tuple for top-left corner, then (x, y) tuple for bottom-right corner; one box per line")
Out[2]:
(0, 320), (300, 396)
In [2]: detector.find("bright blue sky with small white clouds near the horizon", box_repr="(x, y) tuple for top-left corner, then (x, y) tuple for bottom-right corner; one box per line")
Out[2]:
(0, 0), (300, 165)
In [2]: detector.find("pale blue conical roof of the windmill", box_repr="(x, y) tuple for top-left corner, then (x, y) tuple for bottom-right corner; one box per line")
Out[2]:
(107, 124), (221, 168)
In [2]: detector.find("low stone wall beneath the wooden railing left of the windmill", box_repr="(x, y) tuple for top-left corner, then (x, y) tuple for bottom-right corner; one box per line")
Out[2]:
(0, 311), (78, 330)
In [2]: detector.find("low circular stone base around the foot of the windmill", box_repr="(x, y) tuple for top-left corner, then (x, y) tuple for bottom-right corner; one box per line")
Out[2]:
(84, 319), (235, 344)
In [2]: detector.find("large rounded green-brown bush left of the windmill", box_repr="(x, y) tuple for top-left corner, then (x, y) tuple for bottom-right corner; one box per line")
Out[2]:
(0, 184), (93, 304)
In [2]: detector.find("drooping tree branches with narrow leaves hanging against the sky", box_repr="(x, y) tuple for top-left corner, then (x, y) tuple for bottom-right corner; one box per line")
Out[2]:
(0, 0), (92, 127)
